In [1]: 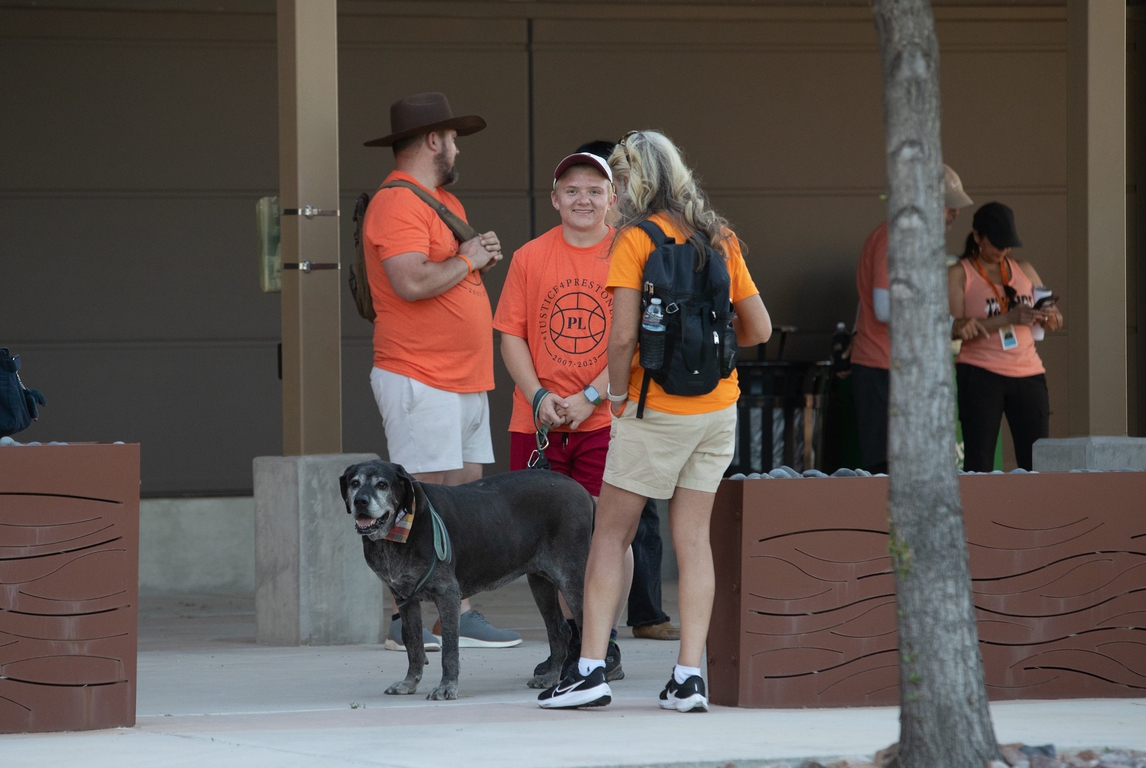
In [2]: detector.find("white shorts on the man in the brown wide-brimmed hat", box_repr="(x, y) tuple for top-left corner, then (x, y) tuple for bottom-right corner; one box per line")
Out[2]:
(370, 368), (494, 473)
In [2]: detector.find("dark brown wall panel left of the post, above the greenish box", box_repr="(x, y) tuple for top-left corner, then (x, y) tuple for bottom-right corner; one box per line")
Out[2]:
(0, 40), (278, 192)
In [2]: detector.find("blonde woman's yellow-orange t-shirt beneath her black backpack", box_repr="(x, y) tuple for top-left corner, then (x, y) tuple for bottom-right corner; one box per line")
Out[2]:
(607, 213), (760, 416)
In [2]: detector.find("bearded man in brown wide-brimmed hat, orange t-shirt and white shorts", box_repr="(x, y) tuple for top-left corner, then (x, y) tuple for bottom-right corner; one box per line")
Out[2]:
(362, 93), (521, 650)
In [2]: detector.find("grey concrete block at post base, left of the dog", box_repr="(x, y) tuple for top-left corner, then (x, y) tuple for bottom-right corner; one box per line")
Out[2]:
(254, 454), (386, 645)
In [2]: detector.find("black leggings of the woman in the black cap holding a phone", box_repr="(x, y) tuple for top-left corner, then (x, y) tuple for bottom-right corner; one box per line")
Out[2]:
(955, 362), (1051, 472)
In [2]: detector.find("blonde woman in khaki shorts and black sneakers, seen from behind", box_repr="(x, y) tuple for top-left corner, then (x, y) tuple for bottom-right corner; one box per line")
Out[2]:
(537, 131), (771, 712)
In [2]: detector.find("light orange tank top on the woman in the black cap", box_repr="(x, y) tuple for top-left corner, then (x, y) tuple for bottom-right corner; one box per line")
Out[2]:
(956, 258), (1046, 377)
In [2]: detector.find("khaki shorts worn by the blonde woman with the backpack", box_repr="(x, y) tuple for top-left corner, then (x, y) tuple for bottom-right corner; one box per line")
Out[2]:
(604, 401), (736, 499)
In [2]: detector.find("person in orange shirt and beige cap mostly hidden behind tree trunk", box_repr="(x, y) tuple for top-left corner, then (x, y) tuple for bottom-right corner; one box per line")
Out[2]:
(851, 165), (972, 473)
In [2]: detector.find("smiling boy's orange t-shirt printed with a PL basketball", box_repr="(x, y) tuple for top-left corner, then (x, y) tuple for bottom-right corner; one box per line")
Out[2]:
(494, 226), (613, 433)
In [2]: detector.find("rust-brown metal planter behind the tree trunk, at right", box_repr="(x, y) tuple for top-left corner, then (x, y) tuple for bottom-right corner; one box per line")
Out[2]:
(708, 472), (1146, 707)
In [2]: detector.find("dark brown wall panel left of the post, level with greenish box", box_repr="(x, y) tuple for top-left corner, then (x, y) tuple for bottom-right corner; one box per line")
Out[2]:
(0, 194), (278, 342)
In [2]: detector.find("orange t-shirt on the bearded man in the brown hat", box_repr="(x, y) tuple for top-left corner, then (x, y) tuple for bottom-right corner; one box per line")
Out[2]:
(362, 171), (494, 392)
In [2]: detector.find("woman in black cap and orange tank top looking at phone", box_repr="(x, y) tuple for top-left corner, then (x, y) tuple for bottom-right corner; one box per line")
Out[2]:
(947, 203), (1062, 472)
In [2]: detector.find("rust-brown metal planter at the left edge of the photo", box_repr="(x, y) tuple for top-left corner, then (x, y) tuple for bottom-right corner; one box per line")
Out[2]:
(0, 444), (140, 734)
